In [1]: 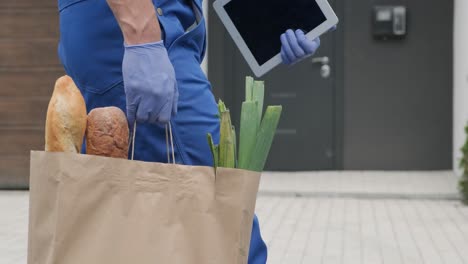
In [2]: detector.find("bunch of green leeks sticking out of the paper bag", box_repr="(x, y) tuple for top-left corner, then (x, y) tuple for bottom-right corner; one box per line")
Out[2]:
(207, 77), (282, 172)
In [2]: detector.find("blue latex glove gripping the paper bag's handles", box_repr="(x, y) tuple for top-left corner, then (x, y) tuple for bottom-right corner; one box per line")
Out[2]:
(122, 41), (179, 127)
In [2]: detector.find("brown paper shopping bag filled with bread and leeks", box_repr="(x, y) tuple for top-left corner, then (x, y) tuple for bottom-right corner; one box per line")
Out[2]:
(28, 151), (260, 264)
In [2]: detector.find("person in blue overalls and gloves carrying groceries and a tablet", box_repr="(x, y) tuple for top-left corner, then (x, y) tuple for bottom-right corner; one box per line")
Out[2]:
(58, 0), (320, 264)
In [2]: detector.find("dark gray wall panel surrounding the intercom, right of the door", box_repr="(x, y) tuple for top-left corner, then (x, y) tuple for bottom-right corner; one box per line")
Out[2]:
(341, 0), (456, 170)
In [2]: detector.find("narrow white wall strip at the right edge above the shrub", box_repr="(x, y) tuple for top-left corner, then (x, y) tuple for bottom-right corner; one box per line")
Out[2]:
(453, 0), (468, 172)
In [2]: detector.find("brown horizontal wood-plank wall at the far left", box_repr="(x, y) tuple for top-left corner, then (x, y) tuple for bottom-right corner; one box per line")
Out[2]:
(0, 0), (63, 188)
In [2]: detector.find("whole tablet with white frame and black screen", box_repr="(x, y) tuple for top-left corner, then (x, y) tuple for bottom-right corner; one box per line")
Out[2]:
(213, 0), (338, 77)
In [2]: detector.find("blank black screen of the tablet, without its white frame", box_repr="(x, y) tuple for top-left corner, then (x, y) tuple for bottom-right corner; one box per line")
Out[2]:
(225, 0), (326, 65)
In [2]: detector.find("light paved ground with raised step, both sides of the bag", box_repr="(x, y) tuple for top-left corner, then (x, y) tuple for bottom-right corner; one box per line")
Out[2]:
(0, 172), (468, 264)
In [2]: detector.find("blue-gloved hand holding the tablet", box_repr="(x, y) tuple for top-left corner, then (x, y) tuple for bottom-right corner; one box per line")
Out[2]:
(280, 26), (336, 65)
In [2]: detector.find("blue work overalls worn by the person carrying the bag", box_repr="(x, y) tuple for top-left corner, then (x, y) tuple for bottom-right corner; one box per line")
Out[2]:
(58, 0), (267, 264)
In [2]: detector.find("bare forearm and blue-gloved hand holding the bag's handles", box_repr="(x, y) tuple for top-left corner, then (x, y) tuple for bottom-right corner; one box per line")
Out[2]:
(107, 0), (179, 127)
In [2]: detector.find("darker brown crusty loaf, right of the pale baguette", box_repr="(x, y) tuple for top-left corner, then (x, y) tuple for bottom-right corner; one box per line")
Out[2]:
(86, 107), (129, 159)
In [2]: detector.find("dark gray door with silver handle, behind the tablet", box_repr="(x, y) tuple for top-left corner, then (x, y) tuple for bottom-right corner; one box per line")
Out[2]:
(209, 0), (335, 170)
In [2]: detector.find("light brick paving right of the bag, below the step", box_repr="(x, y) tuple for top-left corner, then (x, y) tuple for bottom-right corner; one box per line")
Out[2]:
(257, 196), (468, 264)
